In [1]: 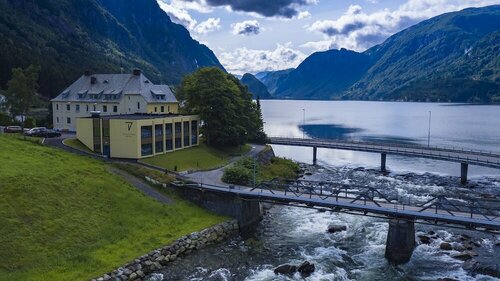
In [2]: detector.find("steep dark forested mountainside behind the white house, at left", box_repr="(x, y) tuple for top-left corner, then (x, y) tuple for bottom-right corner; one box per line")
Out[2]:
(0, 0), (223, 97)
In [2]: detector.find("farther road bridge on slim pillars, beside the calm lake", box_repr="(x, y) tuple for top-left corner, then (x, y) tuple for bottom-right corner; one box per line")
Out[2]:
(269, 137), (500, 183)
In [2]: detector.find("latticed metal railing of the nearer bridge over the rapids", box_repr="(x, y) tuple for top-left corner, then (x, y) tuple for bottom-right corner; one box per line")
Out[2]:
(251, 179), (500, 221)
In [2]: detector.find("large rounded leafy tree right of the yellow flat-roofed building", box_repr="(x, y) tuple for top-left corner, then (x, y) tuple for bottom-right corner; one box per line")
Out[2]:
(177, 67), (265, 147)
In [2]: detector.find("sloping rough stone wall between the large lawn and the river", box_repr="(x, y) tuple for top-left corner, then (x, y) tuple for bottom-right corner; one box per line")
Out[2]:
(92, 220), (239, 281)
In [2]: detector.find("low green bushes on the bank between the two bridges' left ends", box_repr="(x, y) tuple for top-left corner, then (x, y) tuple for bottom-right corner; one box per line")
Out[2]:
(222, 157), (300, 186)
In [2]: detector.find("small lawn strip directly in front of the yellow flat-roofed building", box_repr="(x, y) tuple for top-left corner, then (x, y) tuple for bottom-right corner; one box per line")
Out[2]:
(141, 144), (251, 172)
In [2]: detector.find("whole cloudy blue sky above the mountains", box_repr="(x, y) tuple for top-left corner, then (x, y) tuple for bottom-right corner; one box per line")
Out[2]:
(157, 0), (500, 74)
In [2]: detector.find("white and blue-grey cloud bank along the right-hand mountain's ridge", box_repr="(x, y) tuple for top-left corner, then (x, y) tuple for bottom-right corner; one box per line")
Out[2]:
(303, 0), (498, 51)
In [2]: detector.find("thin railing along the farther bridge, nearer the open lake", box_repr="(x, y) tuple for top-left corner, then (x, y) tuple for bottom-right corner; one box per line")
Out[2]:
(269, 136), (500, 157)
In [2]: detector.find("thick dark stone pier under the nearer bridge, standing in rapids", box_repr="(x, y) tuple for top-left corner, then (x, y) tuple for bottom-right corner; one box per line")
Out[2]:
(385, 219), (415, 265)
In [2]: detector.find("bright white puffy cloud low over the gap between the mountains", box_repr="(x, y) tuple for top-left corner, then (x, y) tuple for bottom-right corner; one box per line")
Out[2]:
(218, 42), (306, 74)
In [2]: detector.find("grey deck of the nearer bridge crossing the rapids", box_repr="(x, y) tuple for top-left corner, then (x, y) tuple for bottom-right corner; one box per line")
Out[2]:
(184, 180), (500, 233)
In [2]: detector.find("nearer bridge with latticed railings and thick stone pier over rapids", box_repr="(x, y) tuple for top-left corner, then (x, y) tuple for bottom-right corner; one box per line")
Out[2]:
(177, 180), (500, 263)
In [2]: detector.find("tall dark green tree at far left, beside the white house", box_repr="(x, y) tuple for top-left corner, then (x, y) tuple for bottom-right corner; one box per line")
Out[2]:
(5, 65), (40, 129)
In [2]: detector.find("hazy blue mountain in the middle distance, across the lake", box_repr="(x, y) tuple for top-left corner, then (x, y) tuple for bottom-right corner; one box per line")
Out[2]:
(274, 49), (371, 99)
